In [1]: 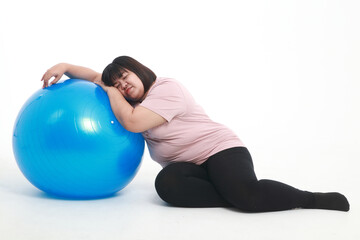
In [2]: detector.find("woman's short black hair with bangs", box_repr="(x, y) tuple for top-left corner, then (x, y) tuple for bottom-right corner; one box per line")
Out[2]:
(101, 56), (156, 92)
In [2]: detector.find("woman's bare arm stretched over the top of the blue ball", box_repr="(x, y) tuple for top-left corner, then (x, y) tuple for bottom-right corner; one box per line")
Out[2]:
(41, 63), (101, 88)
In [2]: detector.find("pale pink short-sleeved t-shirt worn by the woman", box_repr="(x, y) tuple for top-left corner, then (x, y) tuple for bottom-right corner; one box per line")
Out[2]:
(140, 78), (244, 167)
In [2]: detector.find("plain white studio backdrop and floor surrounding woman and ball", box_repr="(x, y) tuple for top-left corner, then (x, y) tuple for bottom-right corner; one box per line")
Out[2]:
(0, 0), (360, 240)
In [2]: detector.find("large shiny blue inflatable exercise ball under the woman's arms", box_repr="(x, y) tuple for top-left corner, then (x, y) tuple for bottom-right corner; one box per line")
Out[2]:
(12, 79), (145, 199)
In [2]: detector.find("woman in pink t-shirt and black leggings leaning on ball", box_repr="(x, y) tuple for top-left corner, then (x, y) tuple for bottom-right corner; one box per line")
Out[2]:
(42, 56), (349, 212)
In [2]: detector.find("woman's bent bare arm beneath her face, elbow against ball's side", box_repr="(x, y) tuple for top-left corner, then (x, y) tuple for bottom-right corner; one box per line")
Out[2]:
(99, 84), (166, 133)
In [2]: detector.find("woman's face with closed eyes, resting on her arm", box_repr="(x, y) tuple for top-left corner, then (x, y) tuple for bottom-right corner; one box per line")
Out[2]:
(114, 70), (145, 102)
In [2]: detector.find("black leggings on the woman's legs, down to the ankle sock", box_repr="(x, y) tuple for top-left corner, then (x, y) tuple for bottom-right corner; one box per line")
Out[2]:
(155, 147), (314, 212)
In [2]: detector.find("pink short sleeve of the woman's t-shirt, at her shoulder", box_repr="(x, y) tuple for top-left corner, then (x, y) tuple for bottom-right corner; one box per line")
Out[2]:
(139, 79), (186, 122)
